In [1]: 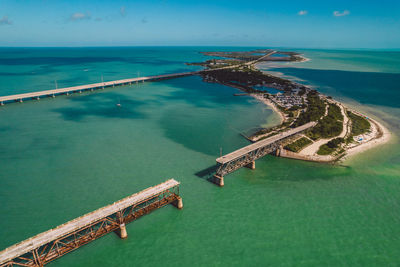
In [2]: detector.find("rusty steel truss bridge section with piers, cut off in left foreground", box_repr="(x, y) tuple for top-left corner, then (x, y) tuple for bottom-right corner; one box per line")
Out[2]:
(0, 179), (183, 266)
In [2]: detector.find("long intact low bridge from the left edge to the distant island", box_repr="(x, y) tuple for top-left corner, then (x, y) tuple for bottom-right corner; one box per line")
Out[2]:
(0, 51), (276, 105)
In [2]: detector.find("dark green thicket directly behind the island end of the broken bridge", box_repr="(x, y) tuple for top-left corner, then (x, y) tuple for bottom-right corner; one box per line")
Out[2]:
(292, 91), (325, 128)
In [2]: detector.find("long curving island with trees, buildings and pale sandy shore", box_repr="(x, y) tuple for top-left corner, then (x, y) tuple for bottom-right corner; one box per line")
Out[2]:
(188, 49), (390, 163)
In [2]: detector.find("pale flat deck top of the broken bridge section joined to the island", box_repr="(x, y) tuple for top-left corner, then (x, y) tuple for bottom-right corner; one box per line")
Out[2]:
(216, 122), (316, 164)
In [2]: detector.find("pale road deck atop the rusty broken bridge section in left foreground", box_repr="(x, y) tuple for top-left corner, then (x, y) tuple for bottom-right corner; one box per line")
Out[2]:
(0, 179), (180, 264)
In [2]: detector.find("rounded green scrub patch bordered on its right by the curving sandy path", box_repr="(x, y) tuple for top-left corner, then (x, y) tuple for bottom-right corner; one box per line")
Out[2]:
(307, 104), (343, 140)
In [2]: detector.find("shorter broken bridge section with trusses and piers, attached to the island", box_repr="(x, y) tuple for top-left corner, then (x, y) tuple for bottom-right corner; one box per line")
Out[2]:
(214, 122), (317, 186)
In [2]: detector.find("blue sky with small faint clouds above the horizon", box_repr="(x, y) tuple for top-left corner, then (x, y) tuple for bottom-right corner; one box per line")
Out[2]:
(0, 0), (400, 49)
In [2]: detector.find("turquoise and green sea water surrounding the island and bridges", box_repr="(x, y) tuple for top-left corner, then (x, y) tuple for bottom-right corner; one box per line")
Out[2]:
(0, 47), (400, 266)
